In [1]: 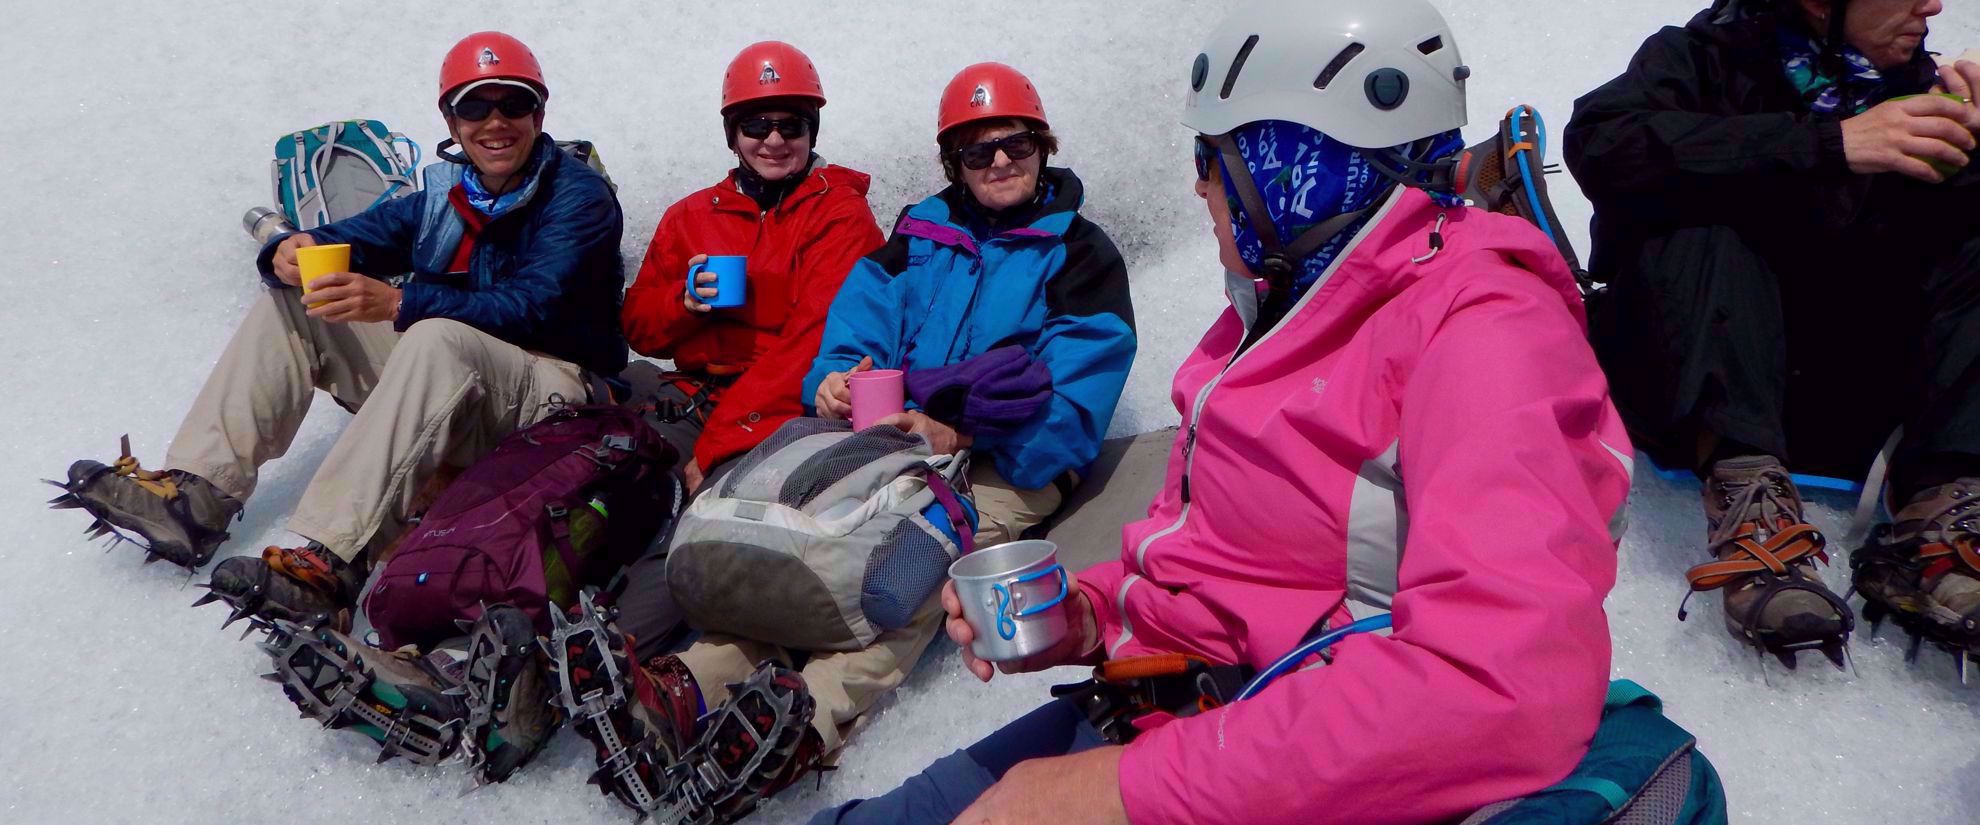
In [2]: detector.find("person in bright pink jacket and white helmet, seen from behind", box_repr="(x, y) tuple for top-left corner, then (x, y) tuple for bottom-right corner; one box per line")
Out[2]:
(814, 0), (1632, 825)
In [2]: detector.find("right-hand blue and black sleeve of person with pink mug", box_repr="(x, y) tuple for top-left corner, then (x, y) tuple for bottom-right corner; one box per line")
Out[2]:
(976, 218), (1135, 491)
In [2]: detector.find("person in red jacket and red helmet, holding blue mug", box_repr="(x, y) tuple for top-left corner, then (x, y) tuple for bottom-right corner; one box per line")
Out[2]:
(618, 42), (885, 661)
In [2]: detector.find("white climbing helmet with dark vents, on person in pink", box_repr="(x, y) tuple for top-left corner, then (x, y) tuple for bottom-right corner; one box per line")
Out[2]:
(1182, 0), (1471, 148)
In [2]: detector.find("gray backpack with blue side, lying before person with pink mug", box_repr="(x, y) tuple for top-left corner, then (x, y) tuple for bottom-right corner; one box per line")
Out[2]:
(667, 417), (976, 651)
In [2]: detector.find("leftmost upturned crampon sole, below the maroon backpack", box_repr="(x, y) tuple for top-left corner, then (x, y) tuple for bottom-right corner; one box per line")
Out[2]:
(251, 619), (463, 766)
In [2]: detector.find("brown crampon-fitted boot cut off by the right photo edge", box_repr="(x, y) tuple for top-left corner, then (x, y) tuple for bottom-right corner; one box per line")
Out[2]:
(1851, 479), (1980, 649)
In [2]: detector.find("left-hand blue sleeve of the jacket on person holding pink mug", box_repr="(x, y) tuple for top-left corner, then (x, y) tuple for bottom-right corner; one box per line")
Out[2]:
(800, 231), (909, 415)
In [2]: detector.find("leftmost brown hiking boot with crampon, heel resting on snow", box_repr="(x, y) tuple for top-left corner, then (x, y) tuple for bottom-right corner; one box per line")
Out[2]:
(48, 435), (242, 570)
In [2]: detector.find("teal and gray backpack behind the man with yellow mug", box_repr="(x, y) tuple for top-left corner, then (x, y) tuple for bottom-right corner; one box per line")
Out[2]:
(271, 121), (420, 229)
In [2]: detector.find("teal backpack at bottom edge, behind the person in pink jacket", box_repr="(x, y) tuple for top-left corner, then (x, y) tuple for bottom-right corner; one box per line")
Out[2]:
(1461, 679), (1727, 825)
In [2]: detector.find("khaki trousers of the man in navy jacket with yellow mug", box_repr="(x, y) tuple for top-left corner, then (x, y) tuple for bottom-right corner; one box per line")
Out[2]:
(164, 289), (588, 560)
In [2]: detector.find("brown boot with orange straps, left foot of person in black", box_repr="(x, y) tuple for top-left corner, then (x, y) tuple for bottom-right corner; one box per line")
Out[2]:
(1677, 455), (1855, 669)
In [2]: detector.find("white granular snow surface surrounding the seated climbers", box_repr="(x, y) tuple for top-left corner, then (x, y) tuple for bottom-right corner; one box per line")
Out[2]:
(0, 0), (1980, 823)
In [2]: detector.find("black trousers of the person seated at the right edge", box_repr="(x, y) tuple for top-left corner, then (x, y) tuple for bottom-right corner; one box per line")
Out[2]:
(1590, 226), (1980, 501)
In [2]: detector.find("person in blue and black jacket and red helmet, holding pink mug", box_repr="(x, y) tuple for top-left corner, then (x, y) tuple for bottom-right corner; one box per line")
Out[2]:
(804, 63), (1135, 546)
